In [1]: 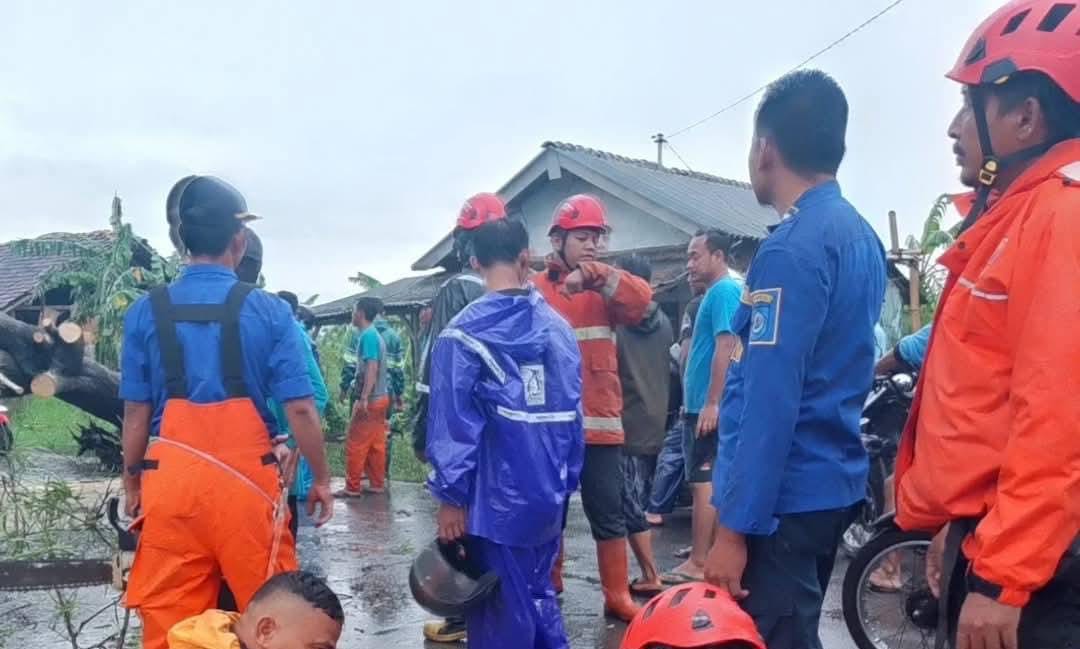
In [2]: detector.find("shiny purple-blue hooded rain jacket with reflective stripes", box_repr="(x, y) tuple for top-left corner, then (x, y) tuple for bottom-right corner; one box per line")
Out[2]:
(427, 289), (585, 547)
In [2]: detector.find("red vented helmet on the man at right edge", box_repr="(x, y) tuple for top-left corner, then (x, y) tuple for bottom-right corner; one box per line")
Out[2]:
(947, 0), (1080, 102)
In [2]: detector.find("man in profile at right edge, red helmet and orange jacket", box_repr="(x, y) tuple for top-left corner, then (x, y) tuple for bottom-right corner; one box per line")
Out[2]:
(896, 0), (1080, 649)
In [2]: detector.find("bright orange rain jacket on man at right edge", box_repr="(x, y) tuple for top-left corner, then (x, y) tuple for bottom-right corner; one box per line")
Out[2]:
(896, 139), (1080, 607)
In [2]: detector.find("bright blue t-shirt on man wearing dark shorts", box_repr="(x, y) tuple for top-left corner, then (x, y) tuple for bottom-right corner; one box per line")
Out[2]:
(684, 275), (743, 415)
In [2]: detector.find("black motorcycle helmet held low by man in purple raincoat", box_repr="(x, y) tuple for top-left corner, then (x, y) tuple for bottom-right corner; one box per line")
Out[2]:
(408, 537), (499, 618)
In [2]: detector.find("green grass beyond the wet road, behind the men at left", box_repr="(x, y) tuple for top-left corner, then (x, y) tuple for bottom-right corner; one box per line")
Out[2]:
(6, 397), (428, 483)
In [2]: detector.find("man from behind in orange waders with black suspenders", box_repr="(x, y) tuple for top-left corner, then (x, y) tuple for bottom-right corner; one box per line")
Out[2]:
(120, 176), (334, 649)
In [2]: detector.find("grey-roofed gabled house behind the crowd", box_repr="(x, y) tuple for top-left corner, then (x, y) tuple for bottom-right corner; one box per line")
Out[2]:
(314, 141), (907, 343)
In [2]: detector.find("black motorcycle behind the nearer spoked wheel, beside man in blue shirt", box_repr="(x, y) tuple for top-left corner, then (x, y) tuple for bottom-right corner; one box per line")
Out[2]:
(842, 374), (916, 557)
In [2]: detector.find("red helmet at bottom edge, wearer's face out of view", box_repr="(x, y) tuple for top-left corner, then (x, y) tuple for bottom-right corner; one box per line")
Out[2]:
(622, 583), (766, 649)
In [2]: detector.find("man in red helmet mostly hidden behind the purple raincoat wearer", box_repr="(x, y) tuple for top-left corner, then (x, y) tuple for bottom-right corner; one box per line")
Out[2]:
(413, 193), (507, 643)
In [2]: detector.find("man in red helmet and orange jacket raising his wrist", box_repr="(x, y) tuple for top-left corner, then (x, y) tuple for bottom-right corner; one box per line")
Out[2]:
(532, 194), (652, 622)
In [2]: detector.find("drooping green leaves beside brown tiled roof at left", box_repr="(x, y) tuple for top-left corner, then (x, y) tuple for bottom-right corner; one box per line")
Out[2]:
(12, 221), (179, 367)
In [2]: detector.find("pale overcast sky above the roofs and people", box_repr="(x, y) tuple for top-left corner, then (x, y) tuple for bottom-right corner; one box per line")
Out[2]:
(0, 0), (999, 299)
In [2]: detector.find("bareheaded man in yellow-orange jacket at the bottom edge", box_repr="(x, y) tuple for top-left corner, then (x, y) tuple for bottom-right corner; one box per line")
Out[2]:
(168, 572), (345, 649)
